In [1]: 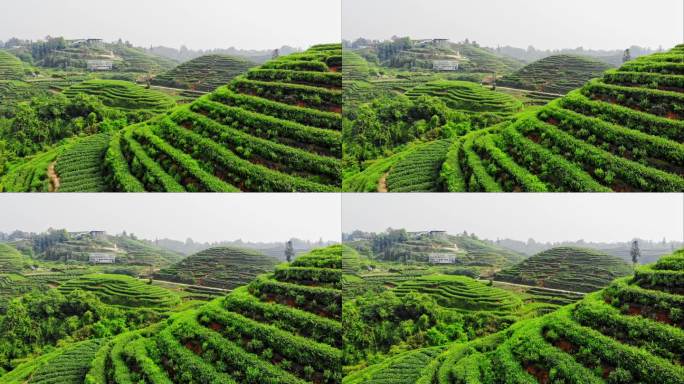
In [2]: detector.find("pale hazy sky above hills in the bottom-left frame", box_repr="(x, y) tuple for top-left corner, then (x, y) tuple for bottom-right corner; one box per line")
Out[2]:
(0, 193), (341, 242)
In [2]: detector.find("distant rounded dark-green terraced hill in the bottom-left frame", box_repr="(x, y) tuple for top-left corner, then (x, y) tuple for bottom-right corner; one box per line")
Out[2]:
(154, 247), (279, 289)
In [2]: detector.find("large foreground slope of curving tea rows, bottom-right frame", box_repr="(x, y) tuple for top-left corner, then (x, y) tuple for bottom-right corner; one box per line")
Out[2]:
(352, 250), (684, 384)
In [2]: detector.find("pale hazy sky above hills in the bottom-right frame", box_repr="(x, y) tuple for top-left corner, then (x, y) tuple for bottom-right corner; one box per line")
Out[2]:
(342, 193), (684, 242)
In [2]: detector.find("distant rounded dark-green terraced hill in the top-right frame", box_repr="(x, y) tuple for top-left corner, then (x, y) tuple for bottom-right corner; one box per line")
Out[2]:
(497, 55), (611, 94)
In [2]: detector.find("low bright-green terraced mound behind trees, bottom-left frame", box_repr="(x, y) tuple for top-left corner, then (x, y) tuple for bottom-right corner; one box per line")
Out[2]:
(59, 274), (180, 310)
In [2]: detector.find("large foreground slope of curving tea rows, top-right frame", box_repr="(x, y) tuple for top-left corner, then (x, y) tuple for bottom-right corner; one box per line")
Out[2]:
(442, 45), (684, 192)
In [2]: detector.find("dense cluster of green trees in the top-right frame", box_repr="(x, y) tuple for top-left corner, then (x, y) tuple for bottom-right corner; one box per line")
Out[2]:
(342, 95), (469, 165)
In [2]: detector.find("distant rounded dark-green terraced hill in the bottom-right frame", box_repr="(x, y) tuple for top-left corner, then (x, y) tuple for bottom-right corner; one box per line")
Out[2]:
(494, 247), (632, 292)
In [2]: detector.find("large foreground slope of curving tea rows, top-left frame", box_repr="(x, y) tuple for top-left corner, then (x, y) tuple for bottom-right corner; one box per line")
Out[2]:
(105, 44), (341, 191)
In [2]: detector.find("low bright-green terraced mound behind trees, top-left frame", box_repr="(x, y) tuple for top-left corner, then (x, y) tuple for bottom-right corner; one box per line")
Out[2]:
(64, 80), (175, 113)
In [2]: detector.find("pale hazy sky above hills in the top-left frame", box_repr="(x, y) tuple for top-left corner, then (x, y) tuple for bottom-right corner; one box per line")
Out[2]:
(0, 0), (341, 49)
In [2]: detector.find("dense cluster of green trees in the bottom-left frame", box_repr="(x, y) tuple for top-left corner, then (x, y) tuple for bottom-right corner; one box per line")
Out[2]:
(0, 289), (161, 374)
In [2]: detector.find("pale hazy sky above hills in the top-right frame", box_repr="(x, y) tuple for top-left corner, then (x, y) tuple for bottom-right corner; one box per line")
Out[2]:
(342, 0), (684, 49)
